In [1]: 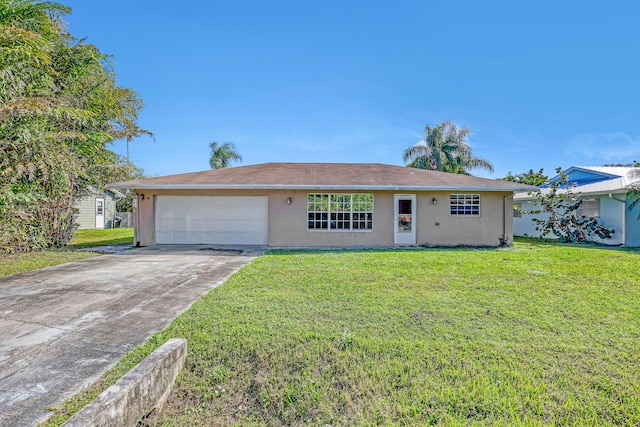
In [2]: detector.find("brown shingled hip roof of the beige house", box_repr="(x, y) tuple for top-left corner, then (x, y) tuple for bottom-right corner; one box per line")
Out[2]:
(110, 163), (537, 192)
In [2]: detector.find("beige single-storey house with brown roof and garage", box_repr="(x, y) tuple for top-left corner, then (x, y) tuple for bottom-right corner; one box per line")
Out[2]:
(111, 163), (536, 251)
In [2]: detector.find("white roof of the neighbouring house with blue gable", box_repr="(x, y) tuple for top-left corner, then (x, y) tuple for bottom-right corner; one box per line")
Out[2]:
(514, 166), (640, 200)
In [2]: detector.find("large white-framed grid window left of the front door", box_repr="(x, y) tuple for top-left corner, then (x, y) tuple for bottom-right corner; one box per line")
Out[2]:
(307, 194), (373, 231)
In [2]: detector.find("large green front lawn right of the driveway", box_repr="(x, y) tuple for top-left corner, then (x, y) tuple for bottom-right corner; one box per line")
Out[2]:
(42, 240), (640, 426)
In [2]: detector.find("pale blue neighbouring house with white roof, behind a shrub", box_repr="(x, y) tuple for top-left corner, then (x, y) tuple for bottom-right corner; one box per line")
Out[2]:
(513, 166), (640, 246)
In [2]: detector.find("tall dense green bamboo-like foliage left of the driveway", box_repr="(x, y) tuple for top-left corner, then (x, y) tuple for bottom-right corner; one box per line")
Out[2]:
(0, 0), (148, 253)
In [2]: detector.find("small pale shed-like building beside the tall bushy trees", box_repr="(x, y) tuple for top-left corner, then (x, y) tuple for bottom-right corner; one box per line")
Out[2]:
(75, 187), (124, 229)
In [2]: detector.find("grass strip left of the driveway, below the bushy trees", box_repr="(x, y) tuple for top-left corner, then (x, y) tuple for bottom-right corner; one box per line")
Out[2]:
(0, 228), (133, 277)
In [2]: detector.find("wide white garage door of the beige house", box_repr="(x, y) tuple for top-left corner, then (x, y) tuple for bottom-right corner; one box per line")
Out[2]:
(155, 196), (268, 245)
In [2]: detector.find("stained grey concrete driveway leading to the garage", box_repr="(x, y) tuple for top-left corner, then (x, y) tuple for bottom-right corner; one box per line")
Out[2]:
(0, 246), (263, 426)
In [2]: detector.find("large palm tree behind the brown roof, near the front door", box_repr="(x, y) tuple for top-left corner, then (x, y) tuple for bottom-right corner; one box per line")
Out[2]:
(402, 120), (493, 175)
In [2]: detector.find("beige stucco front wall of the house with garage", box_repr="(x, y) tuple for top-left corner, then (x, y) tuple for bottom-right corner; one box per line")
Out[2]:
(134, 190), (513, 247)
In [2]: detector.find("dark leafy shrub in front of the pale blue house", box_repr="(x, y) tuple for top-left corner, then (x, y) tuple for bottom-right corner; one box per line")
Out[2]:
(528, 168), (615, 243)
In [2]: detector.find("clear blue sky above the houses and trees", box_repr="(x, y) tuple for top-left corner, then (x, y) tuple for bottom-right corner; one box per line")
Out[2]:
(61, 0), (640, 178)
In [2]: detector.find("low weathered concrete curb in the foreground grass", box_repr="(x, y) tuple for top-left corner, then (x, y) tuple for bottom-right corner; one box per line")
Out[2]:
(63, 338), (187, 427)
